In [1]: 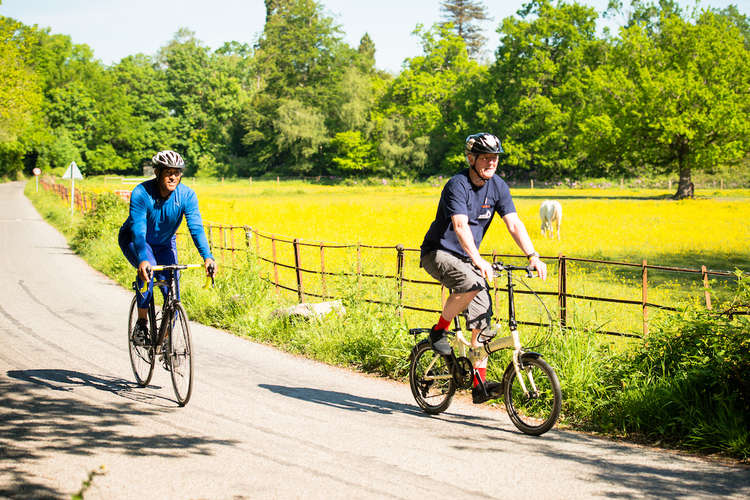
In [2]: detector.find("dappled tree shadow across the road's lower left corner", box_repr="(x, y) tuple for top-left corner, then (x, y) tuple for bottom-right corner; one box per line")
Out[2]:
(0, 369), (237, 498)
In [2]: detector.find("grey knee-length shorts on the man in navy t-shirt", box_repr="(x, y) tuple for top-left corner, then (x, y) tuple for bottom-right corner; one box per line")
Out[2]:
(420, 250), (492, 330)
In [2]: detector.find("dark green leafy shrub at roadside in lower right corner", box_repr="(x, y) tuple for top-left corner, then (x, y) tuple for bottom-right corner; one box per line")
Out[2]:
(595, 272), (750, 458)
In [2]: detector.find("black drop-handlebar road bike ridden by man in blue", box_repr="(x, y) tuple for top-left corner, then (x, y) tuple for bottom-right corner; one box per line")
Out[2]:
(128, 264), (213, 406)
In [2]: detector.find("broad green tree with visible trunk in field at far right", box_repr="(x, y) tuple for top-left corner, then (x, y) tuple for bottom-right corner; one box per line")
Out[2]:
(595, 6), (750, 199)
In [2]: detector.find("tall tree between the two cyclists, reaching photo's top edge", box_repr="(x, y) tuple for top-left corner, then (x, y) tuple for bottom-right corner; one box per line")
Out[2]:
(242, 0), (362, 175)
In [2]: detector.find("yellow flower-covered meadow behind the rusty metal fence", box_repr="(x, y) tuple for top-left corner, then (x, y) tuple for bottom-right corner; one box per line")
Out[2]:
(72, 178), (750, 332)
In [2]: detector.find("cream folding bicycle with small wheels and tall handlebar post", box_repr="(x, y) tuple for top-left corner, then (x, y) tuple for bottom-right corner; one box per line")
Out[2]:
(409, 262), (562, 436)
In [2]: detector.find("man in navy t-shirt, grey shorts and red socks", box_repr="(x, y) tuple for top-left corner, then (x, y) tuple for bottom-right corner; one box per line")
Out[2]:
(420, 133), (547, 403)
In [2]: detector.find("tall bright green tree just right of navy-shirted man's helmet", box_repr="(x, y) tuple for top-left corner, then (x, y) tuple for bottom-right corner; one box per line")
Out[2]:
(488, 0), (607, 178)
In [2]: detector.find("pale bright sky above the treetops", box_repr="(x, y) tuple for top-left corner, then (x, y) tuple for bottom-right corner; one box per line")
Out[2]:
(0, 0), (750, 74)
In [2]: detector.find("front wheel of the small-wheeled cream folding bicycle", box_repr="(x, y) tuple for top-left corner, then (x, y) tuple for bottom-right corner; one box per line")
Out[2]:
(503, 357), (562, 436)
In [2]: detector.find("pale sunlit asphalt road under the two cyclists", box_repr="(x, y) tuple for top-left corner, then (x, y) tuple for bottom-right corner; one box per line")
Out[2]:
(0, 183), (750, 500)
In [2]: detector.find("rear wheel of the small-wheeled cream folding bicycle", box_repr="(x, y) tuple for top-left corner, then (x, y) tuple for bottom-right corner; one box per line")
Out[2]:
(409, 340), (456, 415)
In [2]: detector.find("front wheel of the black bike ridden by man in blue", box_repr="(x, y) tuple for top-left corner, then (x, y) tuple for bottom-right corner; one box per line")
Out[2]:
(166, 303), (193, 406)
